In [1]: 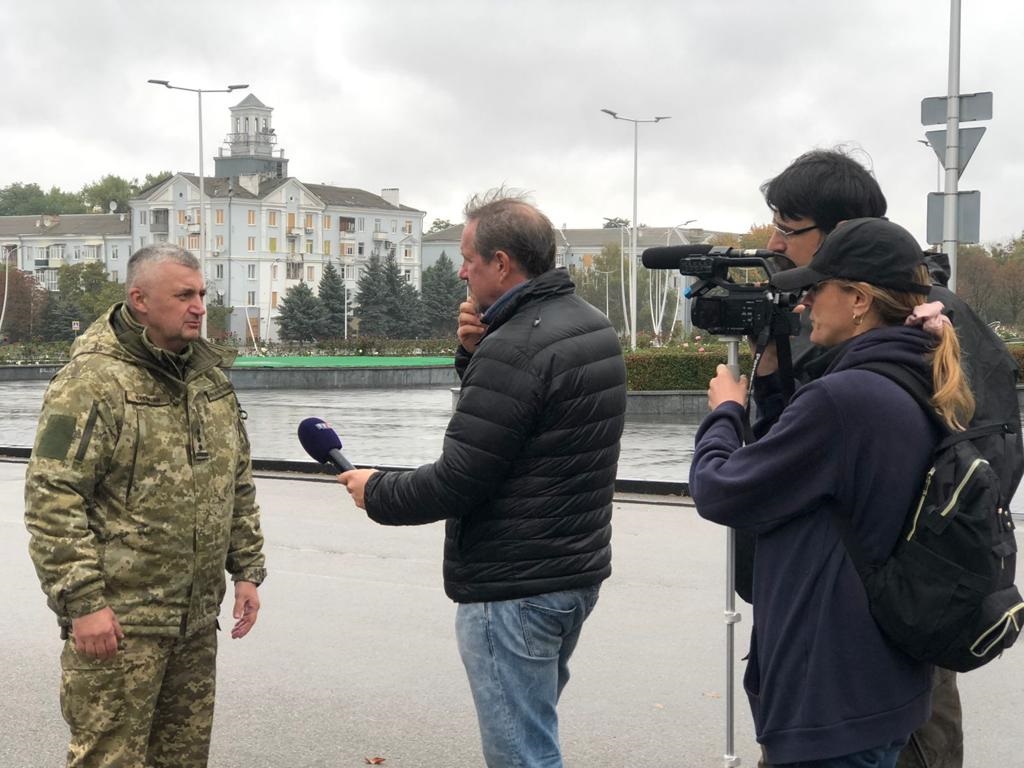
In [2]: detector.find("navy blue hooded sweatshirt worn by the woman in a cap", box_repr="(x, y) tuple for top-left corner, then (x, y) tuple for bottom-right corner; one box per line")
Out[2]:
(690, 327), (938, 764)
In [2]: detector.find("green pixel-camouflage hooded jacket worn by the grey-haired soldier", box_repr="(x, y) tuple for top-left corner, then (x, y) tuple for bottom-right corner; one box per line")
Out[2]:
(25, 304), (265, 635)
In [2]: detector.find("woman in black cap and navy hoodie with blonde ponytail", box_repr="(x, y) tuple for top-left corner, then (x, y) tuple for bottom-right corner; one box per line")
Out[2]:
(690, 219), (974, 768)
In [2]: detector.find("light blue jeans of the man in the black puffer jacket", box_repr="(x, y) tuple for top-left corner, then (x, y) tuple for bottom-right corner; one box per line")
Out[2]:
(455, 586), (600, 768)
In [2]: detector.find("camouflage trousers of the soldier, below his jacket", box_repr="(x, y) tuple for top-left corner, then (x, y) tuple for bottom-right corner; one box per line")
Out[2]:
(60, 627), (217, 768)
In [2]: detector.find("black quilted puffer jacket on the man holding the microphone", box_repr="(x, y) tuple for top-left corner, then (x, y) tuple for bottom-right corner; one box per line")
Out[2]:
(366, 269), (626, 602)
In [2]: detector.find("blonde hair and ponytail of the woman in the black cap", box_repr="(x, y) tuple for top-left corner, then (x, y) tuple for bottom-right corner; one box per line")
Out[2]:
(836, 266), (975, 431)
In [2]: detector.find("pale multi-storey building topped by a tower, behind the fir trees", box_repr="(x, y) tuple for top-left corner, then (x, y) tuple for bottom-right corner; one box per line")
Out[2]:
(131, 94), (426, 341)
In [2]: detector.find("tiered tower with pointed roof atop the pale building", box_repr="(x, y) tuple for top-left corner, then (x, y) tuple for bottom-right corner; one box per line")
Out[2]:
(214, 93), (288, 178)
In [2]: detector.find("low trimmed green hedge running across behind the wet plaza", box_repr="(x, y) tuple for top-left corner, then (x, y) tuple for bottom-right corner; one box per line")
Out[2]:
(0, 338), (1024, 391)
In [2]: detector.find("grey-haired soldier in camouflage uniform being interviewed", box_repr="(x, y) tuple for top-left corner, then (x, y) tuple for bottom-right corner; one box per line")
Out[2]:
(25, 244), (265, 768)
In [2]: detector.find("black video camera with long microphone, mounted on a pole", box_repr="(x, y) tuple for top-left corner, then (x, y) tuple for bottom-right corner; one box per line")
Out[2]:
(642, 244), (803, 338)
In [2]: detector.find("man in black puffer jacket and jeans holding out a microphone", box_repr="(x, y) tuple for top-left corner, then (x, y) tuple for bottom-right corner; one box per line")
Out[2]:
(339, 190), (626, 768)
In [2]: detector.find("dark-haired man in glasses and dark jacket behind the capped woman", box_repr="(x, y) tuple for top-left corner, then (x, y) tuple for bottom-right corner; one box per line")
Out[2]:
(736, 147), (1024, 768)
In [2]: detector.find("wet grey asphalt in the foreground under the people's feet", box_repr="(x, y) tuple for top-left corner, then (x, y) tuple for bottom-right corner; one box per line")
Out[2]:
(0, 463), (1024, 768)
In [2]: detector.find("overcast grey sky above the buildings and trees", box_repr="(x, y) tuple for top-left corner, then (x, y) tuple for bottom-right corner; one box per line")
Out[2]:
(0, 0), (1024, 242)
